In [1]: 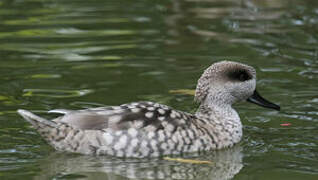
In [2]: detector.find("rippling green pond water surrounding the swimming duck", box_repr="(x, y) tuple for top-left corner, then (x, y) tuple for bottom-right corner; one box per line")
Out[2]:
(0, 0), (318, 180)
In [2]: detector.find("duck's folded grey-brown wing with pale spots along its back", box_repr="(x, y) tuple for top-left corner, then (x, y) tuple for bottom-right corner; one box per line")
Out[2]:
(51, 102), (193, 131)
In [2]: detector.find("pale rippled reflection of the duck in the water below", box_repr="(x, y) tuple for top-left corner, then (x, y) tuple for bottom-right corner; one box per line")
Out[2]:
(35, 145), (243, 180)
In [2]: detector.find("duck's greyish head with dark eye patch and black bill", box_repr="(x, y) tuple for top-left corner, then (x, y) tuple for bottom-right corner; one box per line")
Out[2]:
(195, 61), (280, 110)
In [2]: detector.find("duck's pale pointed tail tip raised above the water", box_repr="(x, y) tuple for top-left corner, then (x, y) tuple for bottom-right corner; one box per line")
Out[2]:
(18, 109), (57, 129)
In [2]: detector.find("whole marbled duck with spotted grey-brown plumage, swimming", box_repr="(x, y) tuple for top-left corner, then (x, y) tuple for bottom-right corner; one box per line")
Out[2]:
(18, 61), (280, 157)
